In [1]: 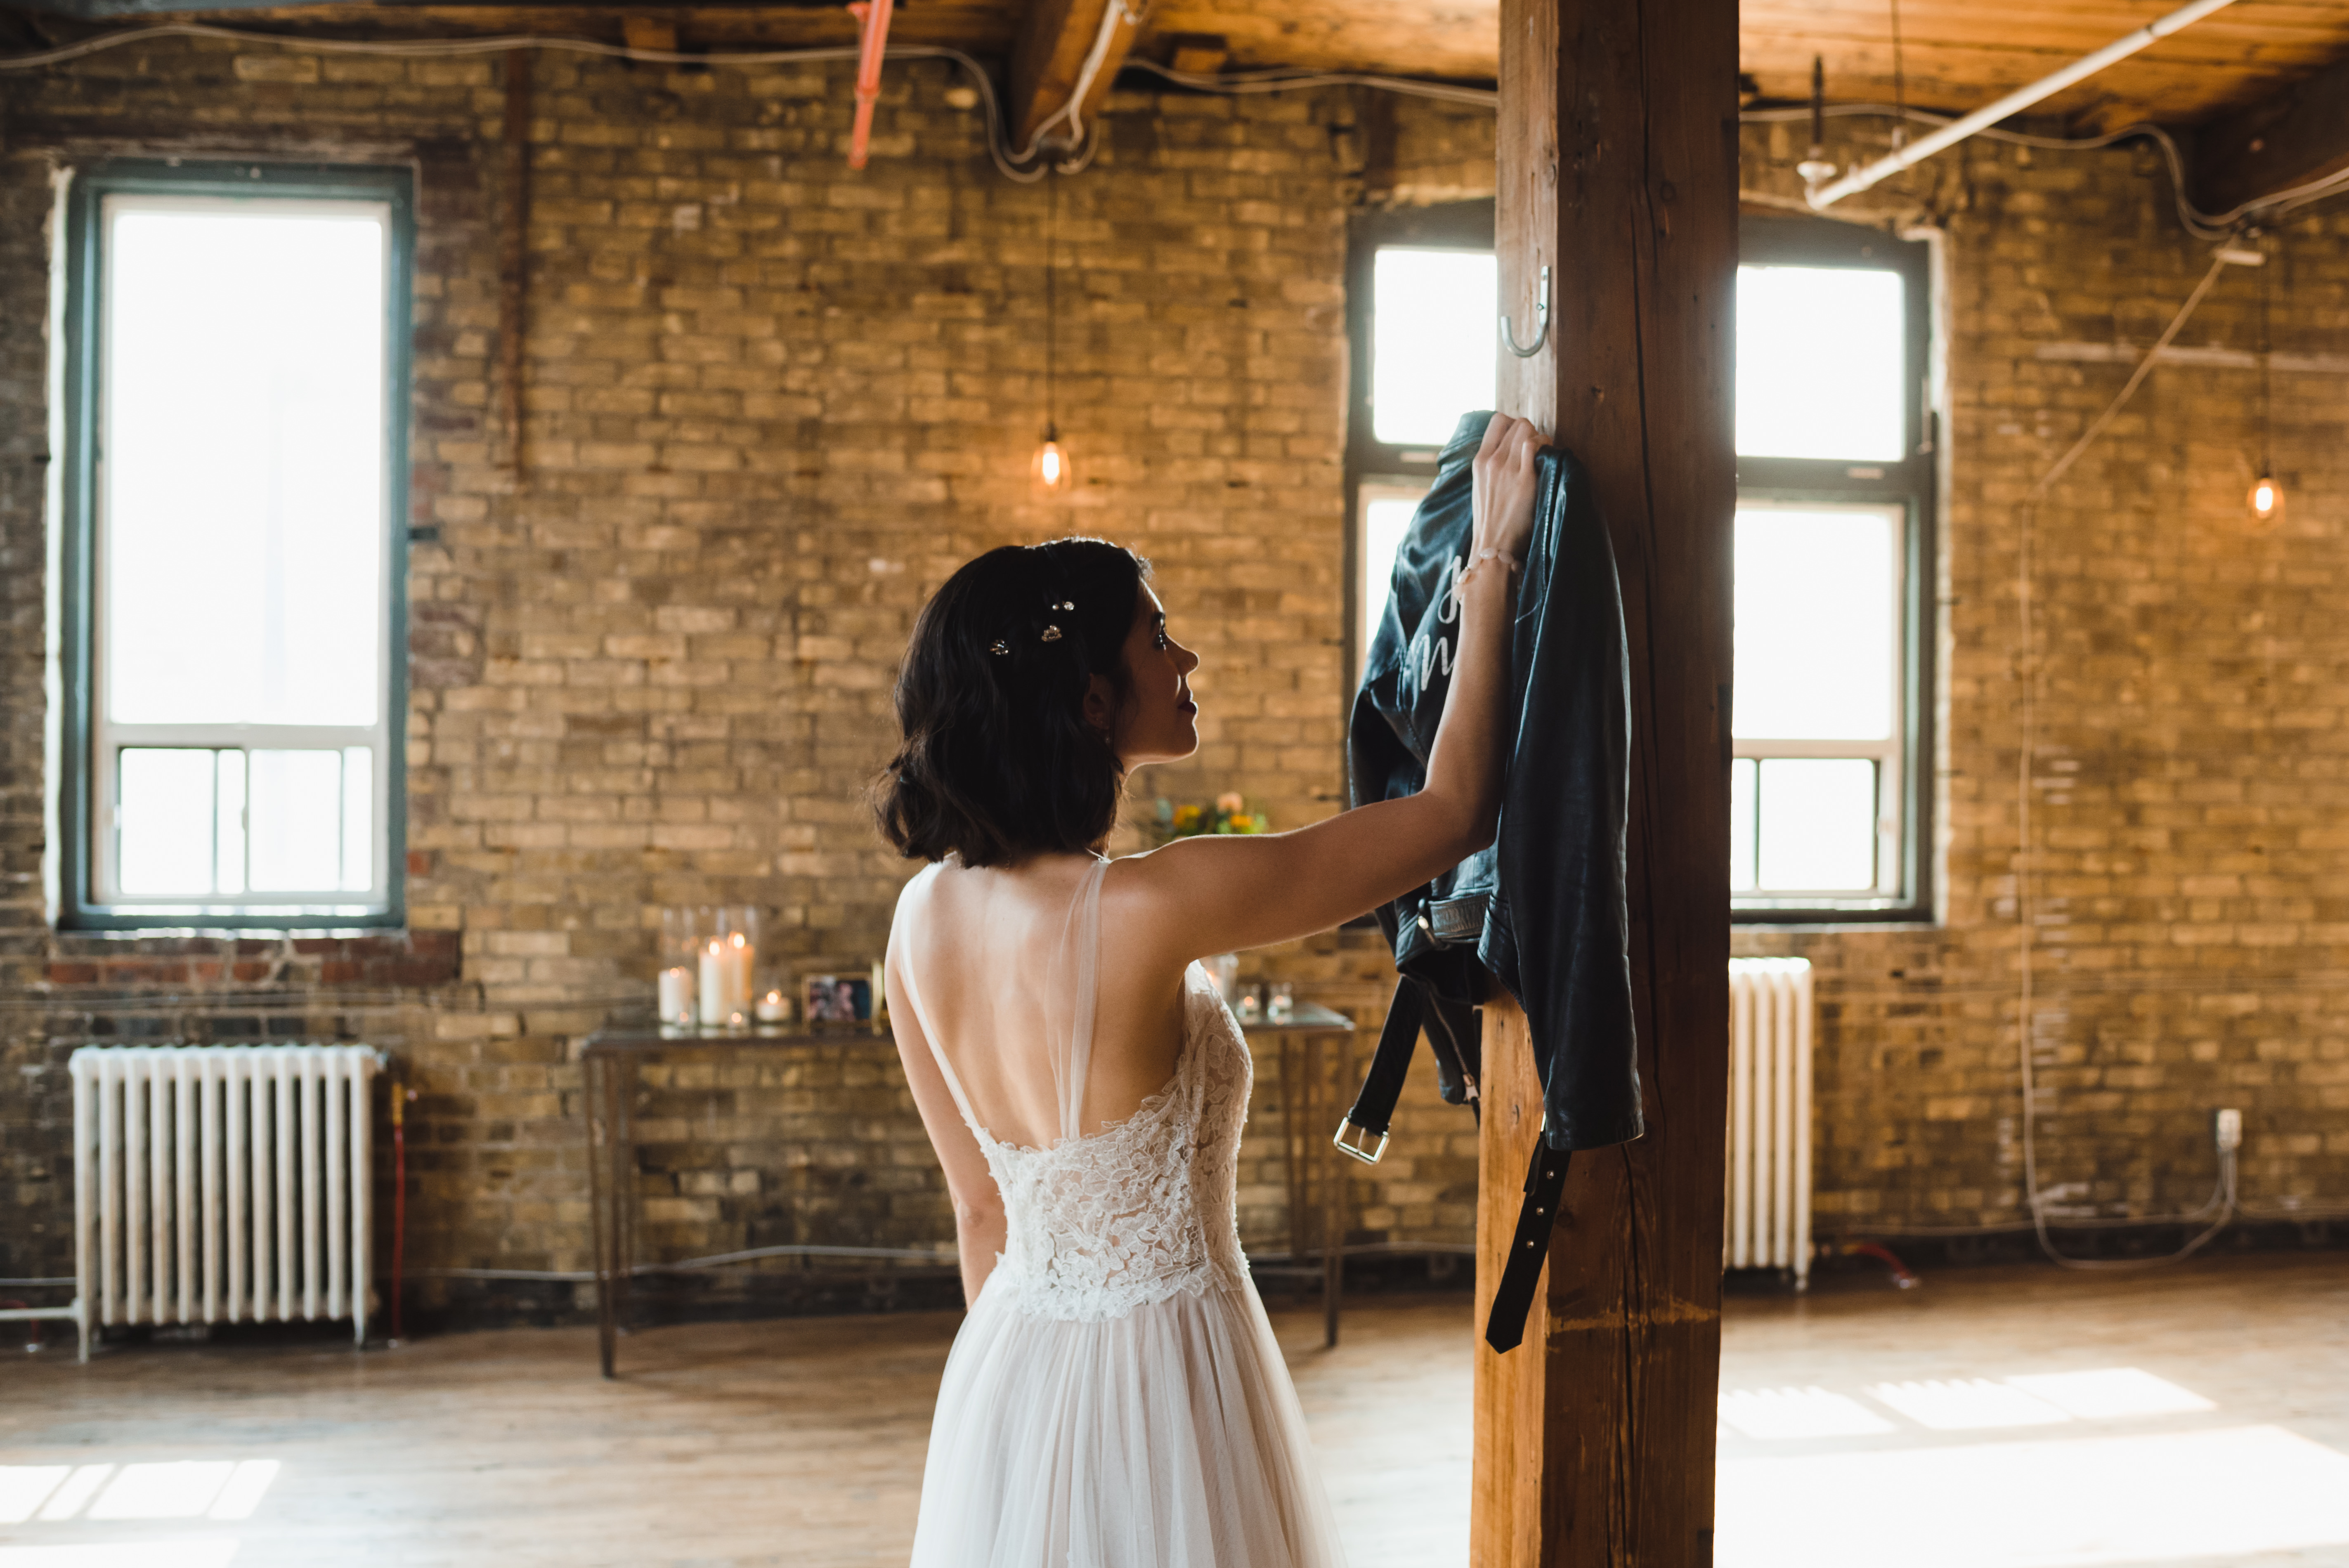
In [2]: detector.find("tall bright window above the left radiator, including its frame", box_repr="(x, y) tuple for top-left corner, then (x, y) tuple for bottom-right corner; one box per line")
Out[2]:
(64, 164), (411, 927)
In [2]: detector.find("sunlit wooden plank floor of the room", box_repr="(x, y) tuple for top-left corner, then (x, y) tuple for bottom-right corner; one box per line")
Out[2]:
(0, 1256), (2349, 1568)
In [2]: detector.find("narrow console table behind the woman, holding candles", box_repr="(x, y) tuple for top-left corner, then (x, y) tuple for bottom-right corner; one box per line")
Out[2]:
(580, 1005), (1353, 1378)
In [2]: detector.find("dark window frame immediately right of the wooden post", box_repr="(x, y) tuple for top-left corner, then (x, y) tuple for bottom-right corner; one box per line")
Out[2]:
(1722, 214), (1940, 925)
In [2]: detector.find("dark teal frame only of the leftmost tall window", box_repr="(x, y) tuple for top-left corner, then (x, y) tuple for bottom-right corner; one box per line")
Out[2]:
(57, 160), (416, 932)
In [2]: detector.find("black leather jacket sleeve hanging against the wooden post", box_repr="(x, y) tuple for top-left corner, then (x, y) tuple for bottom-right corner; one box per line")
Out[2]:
(1480, 449), (1642, 1150)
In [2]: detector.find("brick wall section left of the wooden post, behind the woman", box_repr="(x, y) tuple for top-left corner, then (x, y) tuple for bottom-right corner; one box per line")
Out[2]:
(0, 42), (1491, 1315)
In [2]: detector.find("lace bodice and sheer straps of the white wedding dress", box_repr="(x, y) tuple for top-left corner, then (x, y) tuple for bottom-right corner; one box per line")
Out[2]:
(907, 862), (1252, 1322)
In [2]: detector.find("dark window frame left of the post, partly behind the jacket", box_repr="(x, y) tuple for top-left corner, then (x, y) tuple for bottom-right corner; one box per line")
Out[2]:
(1341, 197), (1501, 680)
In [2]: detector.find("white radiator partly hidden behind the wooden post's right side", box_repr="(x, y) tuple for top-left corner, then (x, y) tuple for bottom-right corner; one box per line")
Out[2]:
(1722, 958), (1811, 1289)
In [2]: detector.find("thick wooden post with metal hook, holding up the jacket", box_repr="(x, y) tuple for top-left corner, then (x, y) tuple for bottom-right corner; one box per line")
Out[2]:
(1470, 0), (1738, 1568)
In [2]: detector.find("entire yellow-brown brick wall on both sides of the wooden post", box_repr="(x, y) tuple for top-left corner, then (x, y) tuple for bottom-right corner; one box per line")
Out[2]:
(0, 42), (2349, 1317)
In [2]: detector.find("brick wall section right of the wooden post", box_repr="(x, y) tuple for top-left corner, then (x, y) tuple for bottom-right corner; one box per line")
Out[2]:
(1736, 122), (2349, 1235)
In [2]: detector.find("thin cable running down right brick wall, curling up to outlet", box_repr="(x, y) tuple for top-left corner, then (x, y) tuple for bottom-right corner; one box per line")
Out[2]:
(2016, 249), (2241, 1270)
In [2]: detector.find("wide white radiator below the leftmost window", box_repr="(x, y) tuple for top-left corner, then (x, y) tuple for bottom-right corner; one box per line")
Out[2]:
(68, 1044), (383, 1357)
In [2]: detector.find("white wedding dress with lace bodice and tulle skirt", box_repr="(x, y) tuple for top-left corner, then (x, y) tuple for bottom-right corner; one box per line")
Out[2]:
(893, 862), (1344, 1568)
